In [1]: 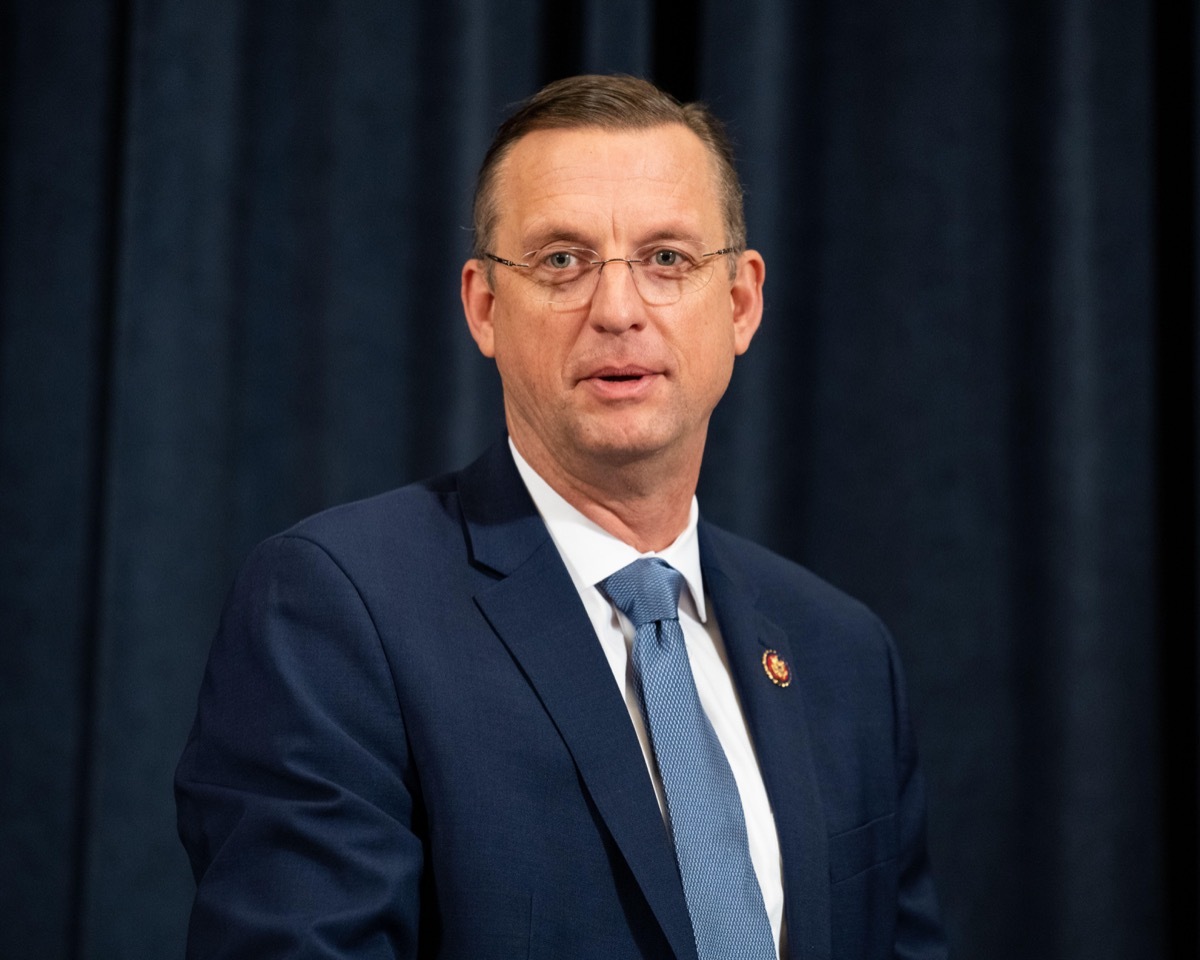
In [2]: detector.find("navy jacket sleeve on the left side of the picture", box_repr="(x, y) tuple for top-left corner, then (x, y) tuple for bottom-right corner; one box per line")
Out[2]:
(175, 535), (424, 960)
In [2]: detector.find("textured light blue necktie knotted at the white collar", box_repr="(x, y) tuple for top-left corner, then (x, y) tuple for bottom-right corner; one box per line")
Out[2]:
(601, 558), (775, 960)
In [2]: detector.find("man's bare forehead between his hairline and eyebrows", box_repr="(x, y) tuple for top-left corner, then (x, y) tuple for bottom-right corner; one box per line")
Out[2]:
(496, 124), (724, 250)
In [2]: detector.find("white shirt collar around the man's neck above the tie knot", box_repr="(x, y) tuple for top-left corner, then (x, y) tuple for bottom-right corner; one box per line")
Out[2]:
(509, 437), (708, 623)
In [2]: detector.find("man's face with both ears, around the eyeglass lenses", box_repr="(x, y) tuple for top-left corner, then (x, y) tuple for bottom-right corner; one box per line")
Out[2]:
(462, 125), (763, 487)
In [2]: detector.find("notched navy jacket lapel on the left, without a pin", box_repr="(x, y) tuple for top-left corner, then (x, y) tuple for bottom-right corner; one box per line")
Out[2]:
(460, 444), (696, 960)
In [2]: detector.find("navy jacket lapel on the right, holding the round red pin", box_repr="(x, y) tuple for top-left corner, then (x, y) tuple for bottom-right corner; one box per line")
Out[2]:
(700, 521), (832, 960)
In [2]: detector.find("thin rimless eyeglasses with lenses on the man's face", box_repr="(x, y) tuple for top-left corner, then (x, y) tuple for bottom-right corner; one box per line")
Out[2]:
(484, 241), (736, 307)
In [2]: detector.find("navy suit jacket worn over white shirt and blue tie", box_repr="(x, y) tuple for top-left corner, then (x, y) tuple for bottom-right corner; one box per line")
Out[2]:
(176, 443), (944, 960)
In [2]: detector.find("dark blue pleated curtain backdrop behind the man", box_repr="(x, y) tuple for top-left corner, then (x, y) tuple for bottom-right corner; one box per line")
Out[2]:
(0, 0), (1200, 960)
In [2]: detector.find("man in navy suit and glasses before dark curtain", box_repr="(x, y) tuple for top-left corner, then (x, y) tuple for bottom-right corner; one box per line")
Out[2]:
(176, 77), (946, 960)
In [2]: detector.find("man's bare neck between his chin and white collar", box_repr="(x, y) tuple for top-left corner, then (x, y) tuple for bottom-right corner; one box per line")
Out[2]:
(512, 437), (703, 553)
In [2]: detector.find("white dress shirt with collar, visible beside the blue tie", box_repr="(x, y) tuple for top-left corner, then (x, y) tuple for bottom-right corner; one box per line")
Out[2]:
(509, 438), (784, 954)
